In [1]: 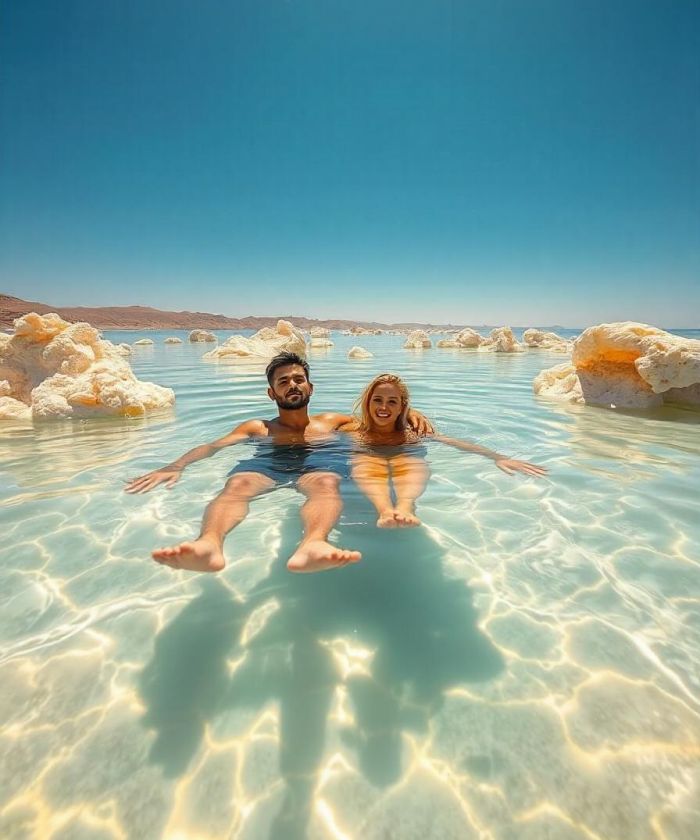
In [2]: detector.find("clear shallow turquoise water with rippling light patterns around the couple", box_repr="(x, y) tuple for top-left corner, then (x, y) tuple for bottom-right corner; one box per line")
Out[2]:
(0, 331), (700, 840)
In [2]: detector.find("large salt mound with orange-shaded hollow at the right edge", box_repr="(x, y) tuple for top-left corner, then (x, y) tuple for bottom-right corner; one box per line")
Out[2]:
(533, 321), (700, 408)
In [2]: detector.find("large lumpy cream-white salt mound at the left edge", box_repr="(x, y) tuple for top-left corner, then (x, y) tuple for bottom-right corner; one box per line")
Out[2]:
(0, 312), (175, 419)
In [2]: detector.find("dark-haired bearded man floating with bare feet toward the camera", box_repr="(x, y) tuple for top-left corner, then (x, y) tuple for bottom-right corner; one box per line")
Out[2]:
(125, 353), (432, 572)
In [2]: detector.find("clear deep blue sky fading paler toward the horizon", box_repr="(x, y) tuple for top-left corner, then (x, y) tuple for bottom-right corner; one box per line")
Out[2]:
(0, 0), (700, 327)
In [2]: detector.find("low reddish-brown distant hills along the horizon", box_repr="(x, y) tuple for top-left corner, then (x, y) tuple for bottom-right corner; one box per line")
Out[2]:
(0, 294), (470, 330)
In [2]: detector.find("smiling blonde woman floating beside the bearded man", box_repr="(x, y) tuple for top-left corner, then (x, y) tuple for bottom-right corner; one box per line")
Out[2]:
(341, 373), (547, 528)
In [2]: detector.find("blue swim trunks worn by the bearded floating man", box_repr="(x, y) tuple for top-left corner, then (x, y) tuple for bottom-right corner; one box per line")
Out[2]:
(229, 442), (350, 487)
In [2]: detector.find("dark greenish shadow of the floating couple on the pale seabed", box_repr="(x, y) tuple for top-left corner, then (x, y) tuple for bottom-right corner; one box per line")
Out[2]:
(140, 502), (503, 840)
